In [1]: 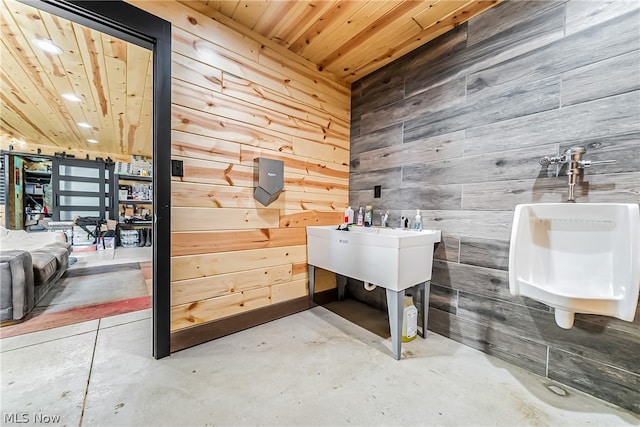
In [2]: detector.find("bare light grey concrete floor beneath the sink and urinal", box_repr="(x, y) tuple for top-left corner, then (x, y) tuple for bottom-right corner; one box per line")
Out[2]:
(0, 307), (640, 426)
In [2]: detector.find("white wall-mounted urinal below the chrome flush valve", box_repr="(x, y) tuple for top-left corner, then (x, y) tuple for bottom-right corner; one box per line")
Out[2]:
(509, 203), (640, 329)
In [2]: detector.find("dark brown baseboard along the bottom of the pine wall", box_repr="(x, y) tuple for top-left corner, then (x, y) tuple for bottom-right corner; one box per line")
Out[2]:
(171, 294), (310, 353)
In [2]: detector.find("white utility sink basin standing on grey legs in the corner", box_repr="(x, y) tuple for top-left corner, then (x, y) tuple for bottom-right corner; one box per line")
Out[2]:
(307, 226), (440, 359)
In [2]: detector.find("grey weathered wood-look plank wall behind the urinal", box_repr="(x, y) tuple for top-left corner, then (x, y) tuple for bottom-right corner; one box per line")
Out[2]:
(349, 1), (640, 412)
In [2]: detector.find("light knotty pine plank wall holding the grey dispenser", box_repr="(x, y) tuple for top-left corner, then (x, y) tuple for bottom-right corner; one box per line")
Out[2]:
(130, 1), (351, 347)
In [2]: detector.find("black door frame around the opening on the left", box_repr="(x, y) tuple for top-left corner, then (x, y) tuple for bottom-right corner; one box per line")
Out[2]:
(19, 0), (171, 359)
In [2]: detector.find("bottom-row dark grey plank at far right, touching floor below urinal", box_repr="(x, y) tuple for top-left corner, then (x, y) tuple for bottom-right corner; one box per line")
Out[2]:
(548, 348), (640, 414)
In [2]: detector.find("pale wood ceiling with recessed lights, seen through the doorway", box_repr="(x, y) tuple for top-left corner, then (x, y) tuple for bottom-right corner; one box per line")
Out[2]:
(0, 0), (153, 159)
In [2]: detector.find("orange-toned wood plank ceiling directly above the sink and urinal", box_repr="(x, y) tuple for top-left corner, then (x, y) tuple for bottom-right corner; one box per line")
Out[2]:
(179, 0), (499, 82)
